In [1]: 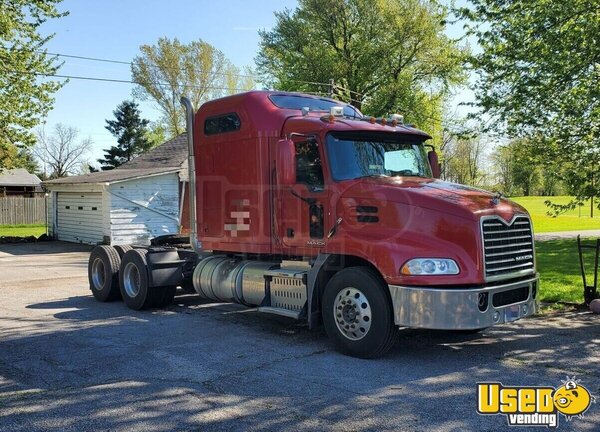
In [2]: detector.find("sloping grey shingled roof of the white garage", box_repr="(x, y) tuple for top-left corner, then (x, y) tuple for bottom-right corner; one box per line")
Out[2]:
(44, 134), (188, 185)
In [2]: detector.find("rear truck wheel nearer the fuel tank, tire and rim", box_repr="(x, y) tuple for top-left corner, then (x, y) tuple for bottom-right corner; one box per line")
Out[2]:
(119, 249), (158, 310)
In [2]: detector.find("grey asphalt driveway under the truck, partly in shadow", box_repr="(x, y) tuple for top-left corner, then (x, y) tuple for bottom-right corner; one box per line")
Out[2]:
(0, 242), (600, 431)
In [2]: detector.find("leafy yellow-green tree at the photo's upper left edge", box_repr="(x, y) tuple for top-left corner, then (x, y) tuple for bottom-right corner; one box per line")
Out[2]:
(0, 0), (67, 168)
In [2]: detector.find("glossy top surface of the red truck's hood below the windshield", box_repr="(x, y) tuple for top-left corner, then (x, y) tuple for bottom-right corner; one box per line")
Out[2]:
(343, 177), (527, 221)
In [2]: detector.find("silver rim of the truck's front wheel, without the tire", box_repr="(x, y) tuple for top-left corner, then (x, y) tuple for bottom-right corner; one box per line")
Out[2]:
(333, 288), (372, 341)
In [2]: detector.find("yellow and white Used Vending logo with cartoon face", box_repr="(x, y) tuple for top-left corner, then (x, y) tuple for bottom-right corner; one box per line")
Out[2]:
(477, 377), (596, 427)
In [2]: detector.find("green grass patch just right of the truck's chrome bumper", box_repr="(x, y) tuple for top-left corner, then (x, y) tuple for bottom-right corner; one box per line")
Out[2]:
(536, 239), (594, 303)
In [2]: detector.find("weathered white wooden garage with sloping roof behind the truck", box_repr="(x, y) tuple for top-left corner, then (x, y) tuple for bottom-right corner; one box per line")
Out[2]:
(44, 134), (187, 245)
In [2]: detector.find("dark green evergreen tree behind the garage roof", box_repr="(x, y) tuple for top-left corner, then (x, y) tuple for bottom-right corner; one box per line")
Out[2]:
(98, 101), (152, 171)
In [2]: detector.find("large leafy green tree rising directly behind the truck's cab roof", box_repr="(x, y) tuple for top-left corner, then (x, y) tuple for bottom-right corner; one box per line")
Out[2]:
(256, 0), (465, 141)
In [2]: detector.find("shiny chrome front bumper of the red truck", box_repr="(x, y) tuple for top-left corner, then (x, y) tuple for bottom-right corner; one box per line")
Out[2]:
(389, 275), (539, 330)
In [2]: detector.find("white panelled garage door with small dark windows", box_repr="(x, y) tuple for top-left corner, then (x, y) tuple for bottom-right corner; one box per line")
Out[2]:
(56, 192), (103, 244)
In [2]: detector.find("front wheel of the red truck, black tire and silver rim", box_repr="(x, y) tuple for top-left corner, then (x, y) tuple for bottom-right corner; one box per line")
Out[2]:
(322, 267), (398, 358)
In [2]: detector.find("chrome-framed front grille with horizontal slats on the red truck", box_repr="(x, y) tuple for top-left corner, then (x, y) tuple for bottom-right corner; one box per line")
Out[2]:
(481, 216), (535, 278)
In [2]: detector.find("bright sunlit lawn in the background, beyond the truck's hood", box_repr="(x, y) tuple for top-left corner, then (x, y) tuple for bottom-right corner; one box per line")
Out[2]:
(510, 196), (600, 233)
